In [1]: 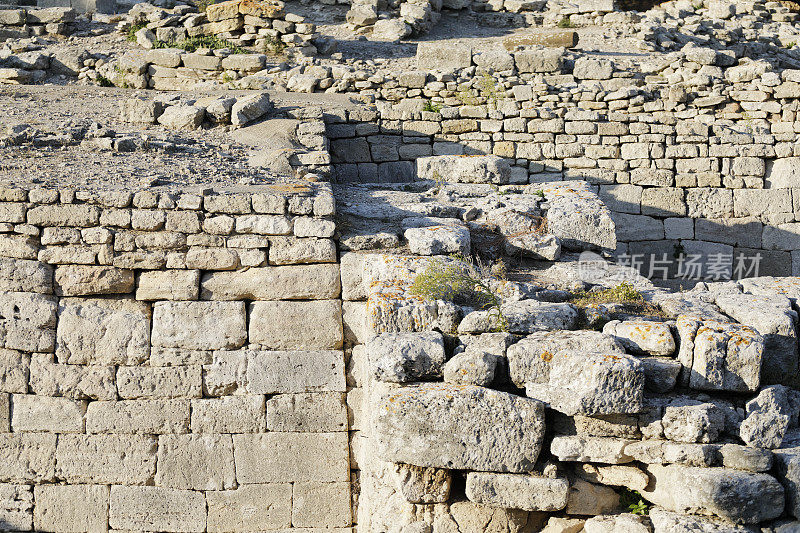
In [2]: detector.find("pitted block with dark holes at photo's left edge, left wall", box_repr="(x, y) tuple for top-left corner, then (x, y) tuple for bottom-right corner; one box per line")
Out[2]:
(0, 292), (56, 352)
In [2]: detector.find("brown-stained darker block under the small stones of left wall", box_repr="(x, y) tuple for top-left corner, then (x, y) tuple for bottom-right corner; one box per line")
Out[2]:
(55, 265), (134, 296)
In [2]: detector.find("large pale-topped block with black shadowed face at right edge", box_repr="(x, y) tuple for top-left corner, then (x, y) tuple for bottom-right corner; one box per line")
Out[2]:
(715, 294), (800, 386)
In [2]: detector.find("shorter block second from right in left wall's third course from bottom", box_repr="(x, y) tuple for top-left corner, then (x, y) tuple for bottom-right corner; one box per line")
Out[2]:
(191, 395), (266, 433)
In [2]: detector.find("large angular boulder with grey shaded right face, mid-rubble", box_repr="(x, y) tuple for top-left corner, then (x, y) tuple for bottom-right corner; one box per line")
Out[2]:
(525, 350), (645, 416)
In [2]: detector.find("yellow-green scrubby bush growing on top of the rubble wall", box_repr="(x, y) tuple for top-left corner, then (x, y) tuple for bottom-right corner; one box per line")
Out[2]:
(410, 255), (508, 332)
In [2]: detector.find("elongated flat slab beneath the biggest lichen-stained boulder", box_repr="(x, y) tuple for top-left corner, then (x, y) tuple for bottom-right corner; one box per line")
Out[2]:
(466, 472), (569, 511)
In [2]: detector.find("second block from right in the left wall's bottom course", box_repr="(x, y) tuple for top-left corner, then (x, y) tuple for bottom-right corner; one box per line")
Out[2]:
(206, 483), (292, 533)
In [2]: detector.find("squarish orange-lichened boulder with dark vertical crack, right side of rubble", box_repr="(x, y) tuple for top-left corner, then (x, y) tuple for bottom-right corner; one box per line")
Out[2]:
(677, 315), (764, 392)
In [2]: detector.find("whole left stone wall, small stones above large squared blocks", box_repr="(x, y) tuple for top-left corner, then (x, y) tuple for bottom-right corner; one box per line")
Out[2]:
(0, 181), (352, 532)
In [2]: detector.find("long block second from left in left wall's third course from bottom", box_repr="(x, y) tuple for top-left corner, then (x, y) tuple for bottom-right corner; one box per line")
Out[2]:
(86, 400), (189, 434)
